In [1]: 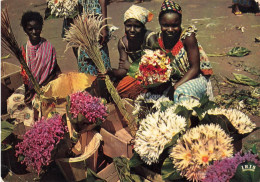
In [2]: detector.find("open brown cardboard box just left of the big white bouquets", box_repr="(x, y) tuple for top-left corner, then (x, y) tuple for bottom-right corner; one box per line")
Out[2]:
(100, 128), (133, 158)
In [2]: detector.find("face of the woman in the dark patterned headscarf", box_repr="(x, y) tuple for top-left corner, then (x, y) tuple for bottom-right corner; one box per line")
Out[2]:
(159, 13), (181, 39)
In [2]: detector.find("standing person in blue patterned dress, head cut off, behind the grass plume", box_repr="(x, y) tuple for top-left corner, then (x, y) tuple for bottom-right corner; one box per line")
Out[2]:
(62, 0), (111, 76)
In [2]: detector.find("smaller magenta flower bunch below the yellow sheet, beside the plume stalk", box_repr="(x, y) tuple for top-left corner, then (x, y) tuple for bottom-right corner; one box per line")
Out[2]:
(70, 91), (107, 123)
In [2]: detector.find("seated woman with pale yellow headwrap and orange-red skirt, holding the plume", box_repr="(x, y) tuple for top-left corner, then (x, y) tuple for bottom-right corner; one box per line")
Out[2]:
(109, 5), (156, 99)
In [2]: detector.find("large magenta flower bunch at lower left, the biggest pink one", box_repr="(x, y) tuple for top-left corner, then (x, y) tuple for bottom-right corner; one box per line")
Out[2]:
(16, 114), (67, 175)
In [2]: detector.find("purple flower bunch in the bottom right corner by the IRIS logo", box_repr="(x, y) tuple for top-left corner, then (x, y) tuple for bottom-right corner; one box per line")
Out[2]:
(203, 152), (260, 182)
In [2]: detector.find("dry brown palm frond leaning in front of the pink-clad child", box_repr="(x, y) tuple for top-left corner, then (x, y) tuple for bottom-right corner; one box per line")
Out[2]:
(1, 8), (40, 95)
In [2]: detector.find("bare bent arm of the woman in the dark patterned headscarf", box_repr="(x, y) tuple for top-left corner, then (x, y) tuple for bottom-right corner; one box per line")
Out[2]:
(174, 33), (200, 90)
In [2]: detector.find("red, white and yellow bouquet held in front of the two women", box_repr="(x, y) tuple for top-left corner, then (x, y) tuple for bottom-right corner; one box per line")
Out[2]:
(136, 49), (172, 86)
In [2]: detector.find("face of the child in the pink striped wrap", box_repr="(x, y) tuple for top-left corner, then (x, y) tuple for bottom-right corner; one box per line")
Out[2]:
(25, 20), (42, 41)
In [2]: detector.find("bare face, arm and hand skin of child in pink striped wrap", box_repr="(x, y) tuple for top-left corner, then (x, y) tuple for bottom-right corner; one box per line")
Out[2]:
(24, 20), (60, 104)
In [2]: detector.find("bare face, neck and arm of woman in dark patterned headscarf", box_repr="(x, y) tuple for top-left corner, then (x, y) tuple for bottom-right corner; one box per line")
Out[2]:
(159, 13), (200, 90)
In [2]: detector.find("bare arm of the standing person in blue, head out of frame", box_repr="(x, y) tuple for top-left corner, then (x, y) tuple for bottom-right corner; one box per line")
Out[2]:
(98, 0), (109, 45)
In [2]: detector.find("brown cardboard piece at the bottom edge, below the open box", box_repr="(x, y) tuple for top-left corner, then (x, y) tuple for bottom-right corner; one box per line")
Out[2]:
(97, 163), (120, 182)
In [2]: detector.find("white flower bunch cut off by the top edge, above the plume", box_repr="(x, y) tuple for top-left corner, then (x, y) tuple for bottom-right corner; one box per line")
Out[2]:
(47, 0), (78, 18)
